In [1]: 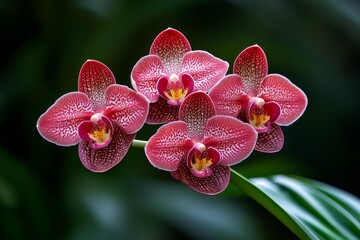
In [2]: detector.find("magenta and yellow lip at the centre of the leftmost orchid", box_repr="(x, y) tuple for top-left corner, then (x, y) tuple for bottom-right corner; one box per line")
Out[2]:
(78, 113), (114, 150)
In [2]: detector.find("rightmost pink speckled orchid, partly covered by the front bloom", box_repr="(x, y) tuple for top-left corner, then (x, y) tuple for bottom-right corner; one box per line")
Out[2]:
(209, 45), (307, 152)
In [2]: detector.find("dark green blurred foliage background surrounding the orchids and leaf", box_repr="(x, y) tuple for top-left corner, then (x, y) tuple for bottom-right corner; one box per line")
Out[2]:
(0, 0), (360, 239)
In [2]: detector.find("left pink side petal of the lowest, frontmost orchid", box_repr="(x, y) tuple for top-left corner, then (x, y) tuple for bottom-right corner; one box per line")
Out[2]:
(145, 121), (192, 171)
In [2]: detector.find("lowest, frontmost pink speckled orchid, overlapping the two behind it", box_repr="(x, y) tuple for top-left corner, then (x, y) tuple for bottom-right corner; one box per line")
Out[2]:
(145, 91), (257, 194)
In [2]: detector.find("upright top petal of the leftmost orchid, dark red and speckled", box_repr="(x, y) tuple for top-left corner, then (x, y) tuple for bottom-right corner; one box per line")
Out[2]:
(78, 60), (116, 111)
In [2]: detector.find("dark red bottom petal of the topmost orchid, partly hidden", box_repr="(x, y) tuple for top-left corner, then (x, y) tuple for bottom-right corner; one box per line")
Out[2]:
(146, 97), (180, 124)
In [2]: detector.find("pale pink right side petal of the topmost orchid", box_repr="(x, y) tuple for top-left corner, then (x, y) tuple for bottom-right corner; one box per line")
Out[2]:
(182, 51), (229, 92)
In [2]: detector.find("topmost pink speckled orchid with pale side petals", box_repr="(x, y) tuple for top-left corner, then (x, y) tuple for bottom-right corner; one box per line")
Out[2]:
(131, 28), (229, 124)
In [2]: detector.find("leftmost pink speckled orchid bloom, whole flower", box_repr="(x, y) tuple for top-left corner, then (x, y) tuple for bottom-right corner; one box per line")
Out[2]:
(37, 60), (149, 172)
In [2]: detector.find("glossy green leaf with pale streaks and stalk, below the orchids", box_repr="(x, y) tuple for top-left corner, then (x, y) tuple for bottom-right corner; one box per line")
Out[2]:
(231, 170), (360, 240)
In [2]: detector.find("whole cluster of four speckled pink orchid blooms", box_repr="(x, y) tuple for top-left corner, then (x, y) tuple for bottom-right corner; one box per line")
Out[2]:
(37, 28), (307, 194)
